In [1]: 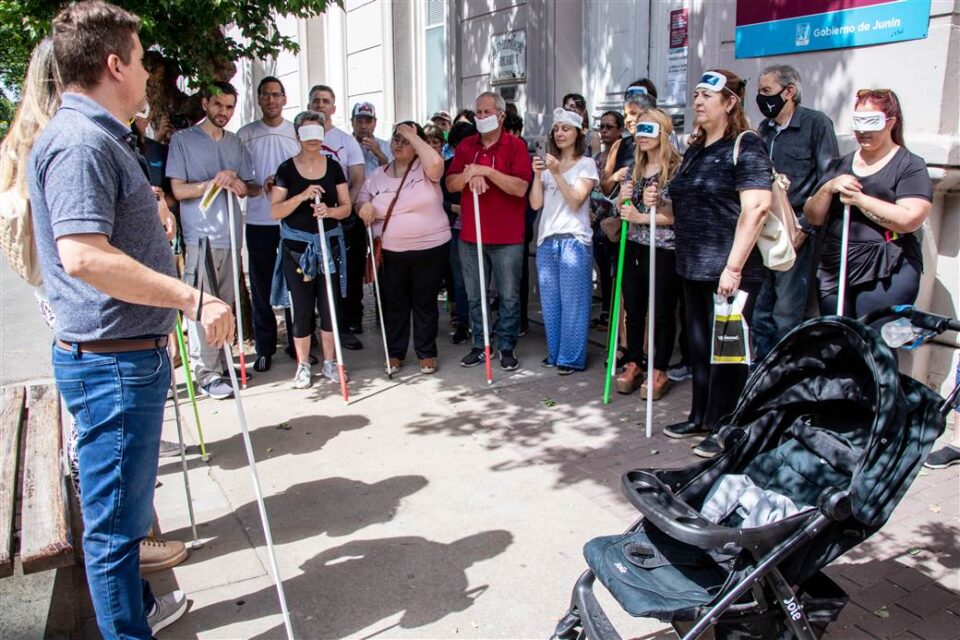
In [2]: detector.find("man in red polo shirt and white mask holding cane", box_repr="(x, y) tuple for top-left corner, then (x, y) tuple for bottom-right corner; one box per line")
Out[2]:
(446, 91), (532, 371)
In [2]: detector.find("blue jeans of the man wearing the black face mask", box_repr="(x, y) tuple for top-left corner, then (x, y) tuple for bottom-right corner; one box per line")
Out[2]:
(750, 237), (816, 362)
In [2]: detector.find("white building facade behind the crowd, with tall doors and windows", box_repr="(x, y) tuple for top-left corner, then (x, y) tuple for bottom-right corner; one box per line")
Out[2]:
(235, 0), (960, 396)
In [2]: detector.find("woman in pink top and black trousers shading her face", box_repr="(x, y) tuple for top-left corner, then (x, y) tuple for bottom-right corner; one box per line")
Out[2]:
(356, 122), (450, 373)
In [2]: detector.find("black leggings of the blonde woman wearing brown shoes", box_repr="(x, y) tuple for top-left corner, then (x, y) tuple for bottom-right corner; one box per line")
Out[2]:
(622, 241), (680, 371)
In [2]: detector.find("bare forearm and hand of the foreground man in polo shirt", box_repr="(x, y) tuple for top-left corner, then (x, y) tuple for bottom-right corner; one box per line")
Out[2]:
(57, 233), (233, 347)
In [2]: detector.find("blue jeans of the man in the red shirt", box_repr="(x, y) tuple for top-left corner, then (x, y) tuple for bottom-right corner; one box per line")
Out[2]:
(460, 240), (523, 351)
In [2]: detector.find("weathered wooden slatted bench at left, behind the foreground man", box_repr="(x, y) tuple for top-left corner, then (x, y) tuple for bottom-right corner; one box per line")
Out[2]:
(0, 383), (93, 637)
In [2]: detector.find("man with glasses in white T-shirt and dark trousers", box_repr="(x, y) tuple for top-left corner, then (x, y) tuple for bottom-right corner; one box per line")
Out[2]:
(237, 76), (300, 371)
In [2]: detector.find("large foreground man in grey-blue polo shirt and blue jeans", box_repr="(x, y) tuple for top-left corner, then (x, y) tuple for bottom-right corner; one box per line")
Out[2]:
(28, 1), (233, 639)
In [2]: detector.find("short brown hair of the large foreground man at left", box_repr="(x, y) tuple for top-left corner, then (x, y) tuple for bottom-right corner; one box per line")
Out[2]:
(53, 0), (140, 89)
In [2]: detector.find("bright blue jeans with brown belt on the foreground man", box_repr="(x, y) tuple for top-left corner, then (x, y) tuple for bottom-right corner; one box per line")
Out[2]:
(53, 345), (170, 640)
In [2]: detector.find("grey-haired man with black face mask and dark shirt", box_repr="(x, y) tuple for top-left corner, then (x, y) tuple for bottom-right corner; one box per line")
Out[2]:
(751, 65), (839, 360)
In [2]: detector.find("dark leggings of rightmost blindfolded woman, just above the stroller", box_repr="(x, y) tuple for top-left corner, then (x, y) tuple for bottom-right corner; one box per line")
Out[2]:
(817, 258), (920, 328)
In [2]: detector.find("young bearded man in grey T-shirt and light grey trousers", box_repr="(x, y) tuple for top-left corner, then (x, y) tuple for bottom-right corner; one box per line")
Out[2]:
(167, 82), (261, 400)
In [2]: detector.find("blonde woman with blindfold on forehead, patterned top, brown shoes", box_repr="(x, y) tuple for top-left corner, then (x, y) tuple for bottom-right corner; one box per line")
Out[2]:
(617, 109), (680, 400)
